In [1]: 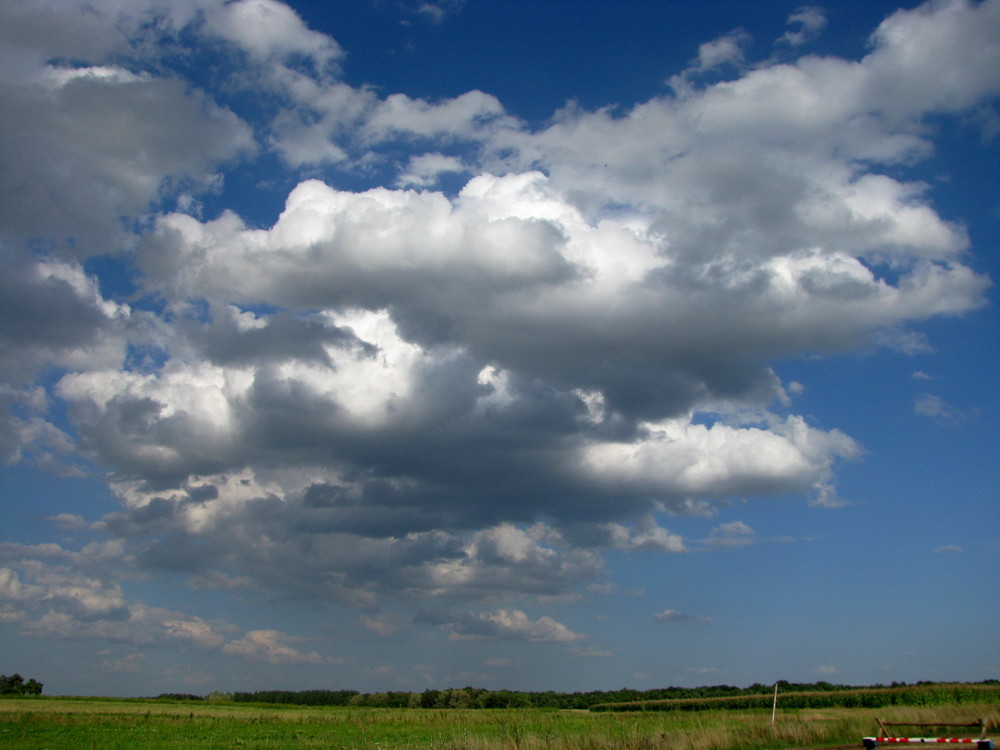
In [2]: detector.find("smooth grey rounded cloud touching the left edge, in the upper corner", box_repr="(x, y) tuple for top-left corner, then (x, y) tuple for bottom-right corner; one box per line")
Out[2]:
(0, 56), (253, 254)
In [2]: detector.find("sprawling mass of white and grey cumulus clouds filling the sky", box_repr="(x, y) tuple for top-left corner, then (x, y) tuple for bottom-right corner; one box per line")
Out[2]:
(0, 0), (1000, 652)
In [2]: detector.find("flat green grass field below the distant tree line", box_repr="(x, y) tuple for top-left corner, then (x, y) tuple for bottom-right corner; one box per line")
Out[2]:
(0, 697), (1000, 750)
